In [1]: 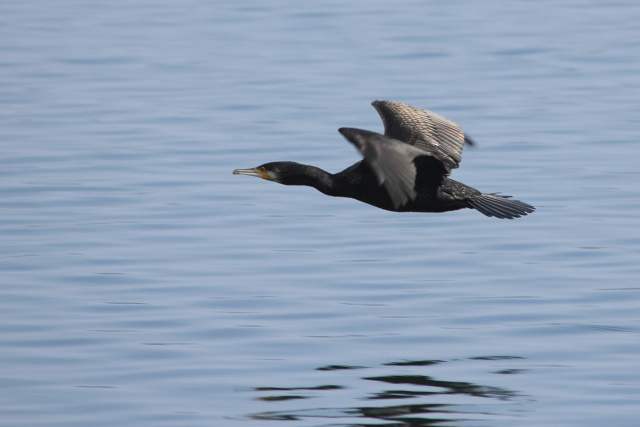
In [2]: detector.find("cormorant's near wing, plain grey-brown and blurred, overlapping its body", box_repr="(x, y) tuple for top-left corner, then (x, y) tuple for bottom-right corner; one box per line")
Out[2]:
(338, 128), (431, 208)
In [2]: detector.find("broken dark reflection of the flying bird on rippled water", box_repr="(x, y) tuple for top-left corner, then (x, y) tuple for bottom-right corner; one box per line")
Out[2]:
(242, 356), (531, 427)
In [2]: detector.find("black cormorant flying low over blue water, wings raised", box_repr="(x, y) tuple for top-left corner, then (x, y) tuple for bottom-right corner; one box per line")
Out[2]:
(233, 101), (535, 219)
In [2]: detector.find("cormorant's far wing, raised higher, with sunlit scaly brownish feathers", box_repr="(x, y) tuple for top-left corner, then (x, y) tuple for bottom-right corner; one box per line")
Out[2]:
(371, 101), (473, 174)
